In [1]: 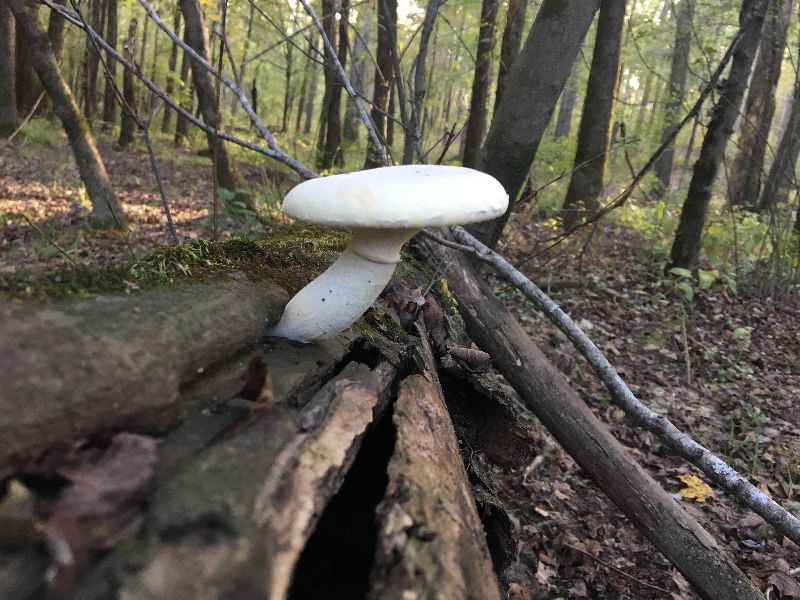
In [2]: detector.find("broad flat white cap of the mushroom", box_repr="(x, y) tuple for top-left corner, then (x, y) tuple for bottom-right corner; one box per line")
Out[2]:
(283, 165), (508, 229)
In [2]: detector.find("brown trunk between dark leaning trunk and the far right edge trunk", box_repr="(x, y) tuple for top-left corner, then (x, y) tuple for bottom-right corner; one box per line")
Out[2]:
(728, 0), (794, 209)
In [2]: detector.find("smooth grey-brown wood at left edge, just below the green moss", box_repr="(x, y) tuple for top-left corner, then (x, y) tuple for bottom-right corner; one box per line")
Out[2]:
(0, 281), (287, 476)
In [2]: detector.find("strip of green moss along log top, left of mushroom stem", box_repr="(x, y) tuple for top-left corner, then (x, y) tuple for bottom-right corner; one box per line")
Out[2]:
(0, 225), (347, 299)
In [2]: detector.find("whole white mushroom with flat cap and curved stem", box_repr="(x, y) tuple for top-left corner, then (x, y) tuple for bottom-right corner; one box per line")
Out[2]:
(267, 165), (508, 342)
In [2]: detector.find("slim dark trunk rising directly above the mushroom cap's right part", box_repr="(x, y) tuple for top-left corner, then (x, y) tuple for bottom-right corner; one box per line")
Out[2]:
(463, 0), (500, 167)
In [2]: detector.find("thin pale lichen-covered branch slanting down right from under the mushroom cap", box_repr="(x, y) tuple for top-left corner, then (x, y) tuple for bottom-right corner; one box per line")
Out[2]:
(432, 227), (800, 545)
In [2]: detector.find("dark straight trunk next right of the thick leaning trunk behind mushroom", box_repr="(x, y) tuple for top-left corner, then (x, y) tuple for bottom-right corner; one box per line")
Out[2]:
(561, 0), (626, 229)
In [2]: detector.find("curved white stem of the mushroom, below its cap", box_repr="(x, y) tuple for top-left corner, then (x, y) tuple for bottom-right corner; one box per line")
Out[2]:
(267, 228), (419, 343)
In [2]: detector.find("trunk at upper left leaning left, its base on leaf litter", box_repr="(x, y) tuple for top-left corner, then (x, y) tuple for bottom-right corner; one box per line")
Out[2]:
(6, 0), (125, 227)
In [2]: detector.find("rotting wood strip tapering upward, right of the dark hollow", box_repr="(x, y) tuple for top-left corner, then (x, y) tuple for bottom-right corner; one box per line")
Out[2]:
(368, 336), (500, 600)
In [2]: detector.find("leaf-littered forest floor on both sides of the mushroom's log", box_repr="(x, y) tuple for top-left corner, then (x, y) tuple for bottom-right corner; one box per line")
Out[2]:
(0, 129), (800, 600)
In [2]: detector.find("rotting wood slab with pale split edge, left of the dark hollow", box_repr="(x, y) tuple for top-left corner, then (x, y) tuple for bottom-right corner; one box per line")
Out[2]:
(78, 358), (395, 600)
